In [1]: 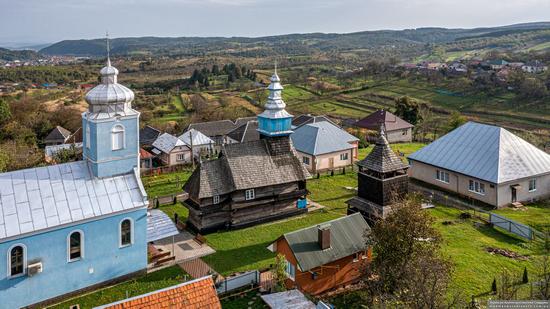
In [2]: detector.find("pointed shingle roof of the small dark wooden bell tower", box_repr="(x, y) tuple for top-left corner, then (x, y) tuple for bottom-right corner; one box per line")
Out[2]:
(357, 132), (408, 173)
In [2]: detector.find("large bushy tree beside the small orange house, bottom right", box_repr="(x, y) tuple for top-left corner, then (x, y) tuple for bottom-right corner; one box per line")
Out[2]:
(365, 196), (452, 308)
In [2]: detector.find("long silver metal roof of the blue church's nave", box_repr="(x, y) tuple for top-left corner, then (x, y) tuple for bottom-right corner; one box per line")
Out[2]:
(0, 161), (148, 242)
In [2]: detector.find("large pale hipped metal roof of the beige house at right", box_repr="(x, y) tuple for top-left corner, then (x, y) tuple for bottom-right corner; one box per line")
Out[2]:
(409, 122), (550, 184)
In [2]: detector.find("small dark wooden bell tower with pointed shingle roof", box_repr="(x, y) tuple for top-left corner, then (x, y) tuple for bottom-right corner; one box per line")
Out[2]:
(346, 129), (409, 223)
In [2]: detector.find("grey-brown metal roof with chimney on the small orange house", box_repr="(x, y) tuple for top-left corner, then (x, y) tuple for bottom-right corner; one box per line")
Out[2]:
(283, 213), (370, 271)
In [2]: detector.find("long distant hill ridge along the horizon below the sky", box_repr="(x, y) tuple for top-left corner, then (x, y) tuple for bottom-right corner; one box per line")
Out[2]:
(40, 22), (550, 57)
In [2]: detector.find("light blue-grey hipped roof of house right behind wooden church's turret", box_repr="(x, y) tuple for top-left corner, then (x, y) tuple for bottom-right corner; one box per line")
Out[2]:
(290, 121), (359, 155)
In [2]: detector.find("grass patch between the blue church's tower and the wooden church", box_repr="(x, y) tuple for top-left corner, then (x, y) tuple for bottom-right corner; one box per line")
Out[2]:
(141, 171), (191, 198)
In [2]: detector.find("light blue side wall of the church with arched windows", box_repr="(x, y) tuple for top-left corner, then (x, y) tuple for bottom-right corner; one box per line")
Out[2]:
(0, 209), (147, 309)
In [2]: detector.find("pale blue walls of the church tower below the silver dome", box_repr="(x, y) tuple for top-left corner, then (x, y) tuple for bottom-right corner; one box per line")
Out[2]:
(82, 114), (139, 177)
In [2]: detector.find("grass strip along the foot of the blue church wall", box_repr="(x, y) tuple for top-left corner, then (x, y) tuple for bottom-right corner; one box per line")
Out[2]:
(51, 266), (192, 309)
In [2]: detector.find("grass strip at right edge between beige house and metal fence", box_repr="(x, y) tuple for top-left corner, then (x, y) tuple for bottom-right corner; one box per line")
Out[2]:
(493, 201), (550, 232)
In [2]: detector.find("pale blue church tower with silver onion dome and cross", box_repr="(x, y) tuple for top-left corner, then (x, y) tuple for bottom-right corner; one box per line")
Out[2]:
(82, 41), (139, 177)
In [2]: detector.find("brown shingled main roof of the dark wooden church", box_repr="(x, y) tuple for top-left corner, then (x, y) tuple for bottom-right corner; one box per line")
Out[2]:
(183, 137), (310, 200)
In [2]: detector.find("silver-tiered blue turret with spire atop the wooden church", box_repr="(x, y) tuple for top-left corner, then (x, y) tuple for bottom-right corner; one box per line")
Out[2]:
(258, 68), (293, 138)
